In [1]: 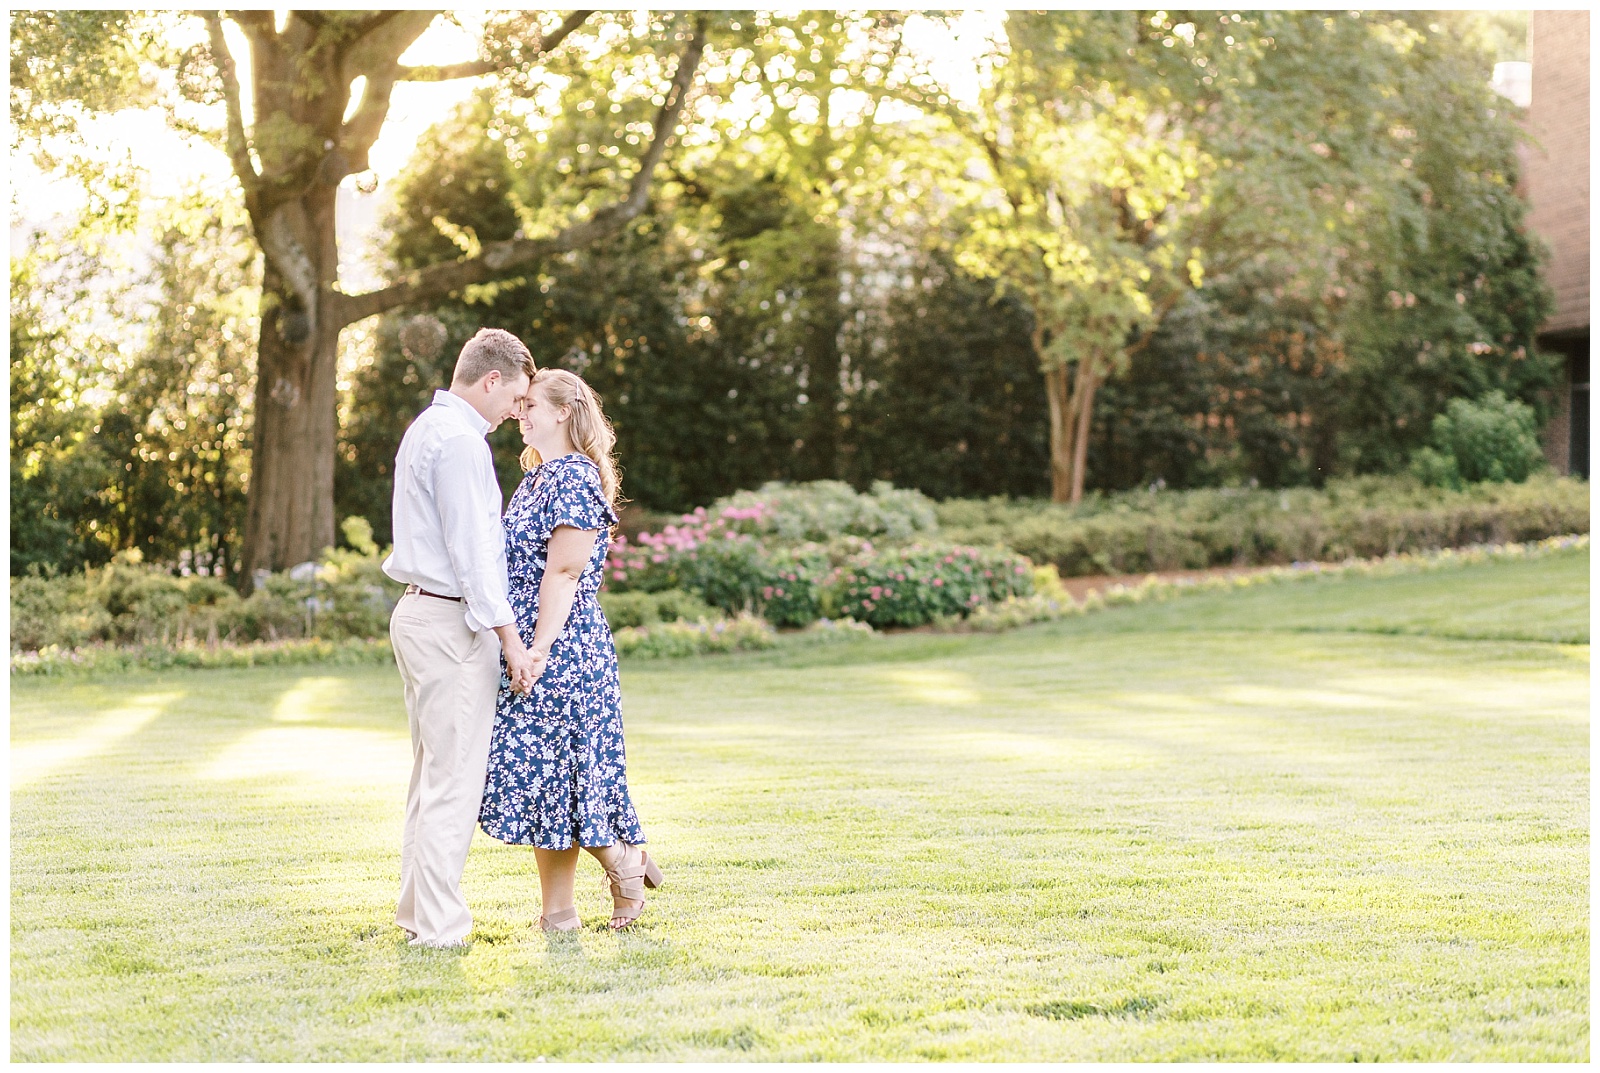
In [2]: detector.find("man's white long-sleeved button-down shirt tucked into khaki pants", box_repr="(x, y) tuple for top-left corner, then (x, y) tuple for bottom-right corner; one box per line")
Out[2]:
(384, 392), (515, 630)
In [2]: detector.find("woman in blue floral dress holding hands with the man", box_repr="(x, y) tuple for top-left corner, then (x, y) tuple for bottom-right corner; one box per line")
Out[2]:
(478, 369), (662, 931)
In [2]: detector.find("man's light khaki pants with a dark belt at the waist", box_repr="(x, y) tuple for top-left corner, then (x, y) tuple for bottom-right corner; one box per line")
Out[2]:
(389, 593), (499, 942)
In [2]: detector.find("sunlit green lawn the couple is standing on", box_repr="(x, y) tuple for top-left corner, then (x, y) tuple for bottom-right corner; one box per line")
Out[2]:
(11, 553), (1589, 1060)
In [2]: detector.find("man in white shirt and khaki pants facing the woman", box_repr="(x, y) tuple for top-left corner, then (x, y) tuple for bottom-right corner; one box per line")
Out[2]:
(384, 328), (534, 947)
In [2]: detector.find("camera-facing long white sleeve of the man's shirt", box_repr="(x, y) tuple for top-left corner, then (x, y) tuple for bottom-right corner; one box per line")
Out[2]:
(434, 435), (517, 630)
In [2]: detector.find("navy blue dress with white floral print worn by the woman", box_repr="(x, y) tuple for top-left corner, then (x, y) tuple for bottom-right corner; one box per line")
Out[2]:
(478, 454), (645, 849)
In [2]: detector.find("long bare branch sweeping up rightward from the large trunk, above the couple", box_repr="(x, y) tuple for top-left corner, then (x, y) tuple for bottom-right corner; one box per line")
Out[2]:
(330, 14), (706, 325)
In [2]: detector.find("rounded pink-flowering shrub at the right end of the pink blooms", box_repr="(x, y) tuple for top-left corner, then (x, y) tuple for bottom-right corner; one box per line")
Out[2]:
(832, 545), (1034, 627)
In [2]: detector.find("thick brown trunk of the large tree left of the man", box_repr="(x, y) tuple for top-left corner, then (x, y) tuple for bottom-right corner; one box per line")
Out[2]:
(243, 185), (344, 585)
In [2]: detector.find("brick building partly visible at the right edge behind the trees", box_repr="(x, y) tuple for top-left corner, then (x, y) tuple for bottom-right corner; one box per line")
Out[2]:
(1520, 11), (1589, 477)
